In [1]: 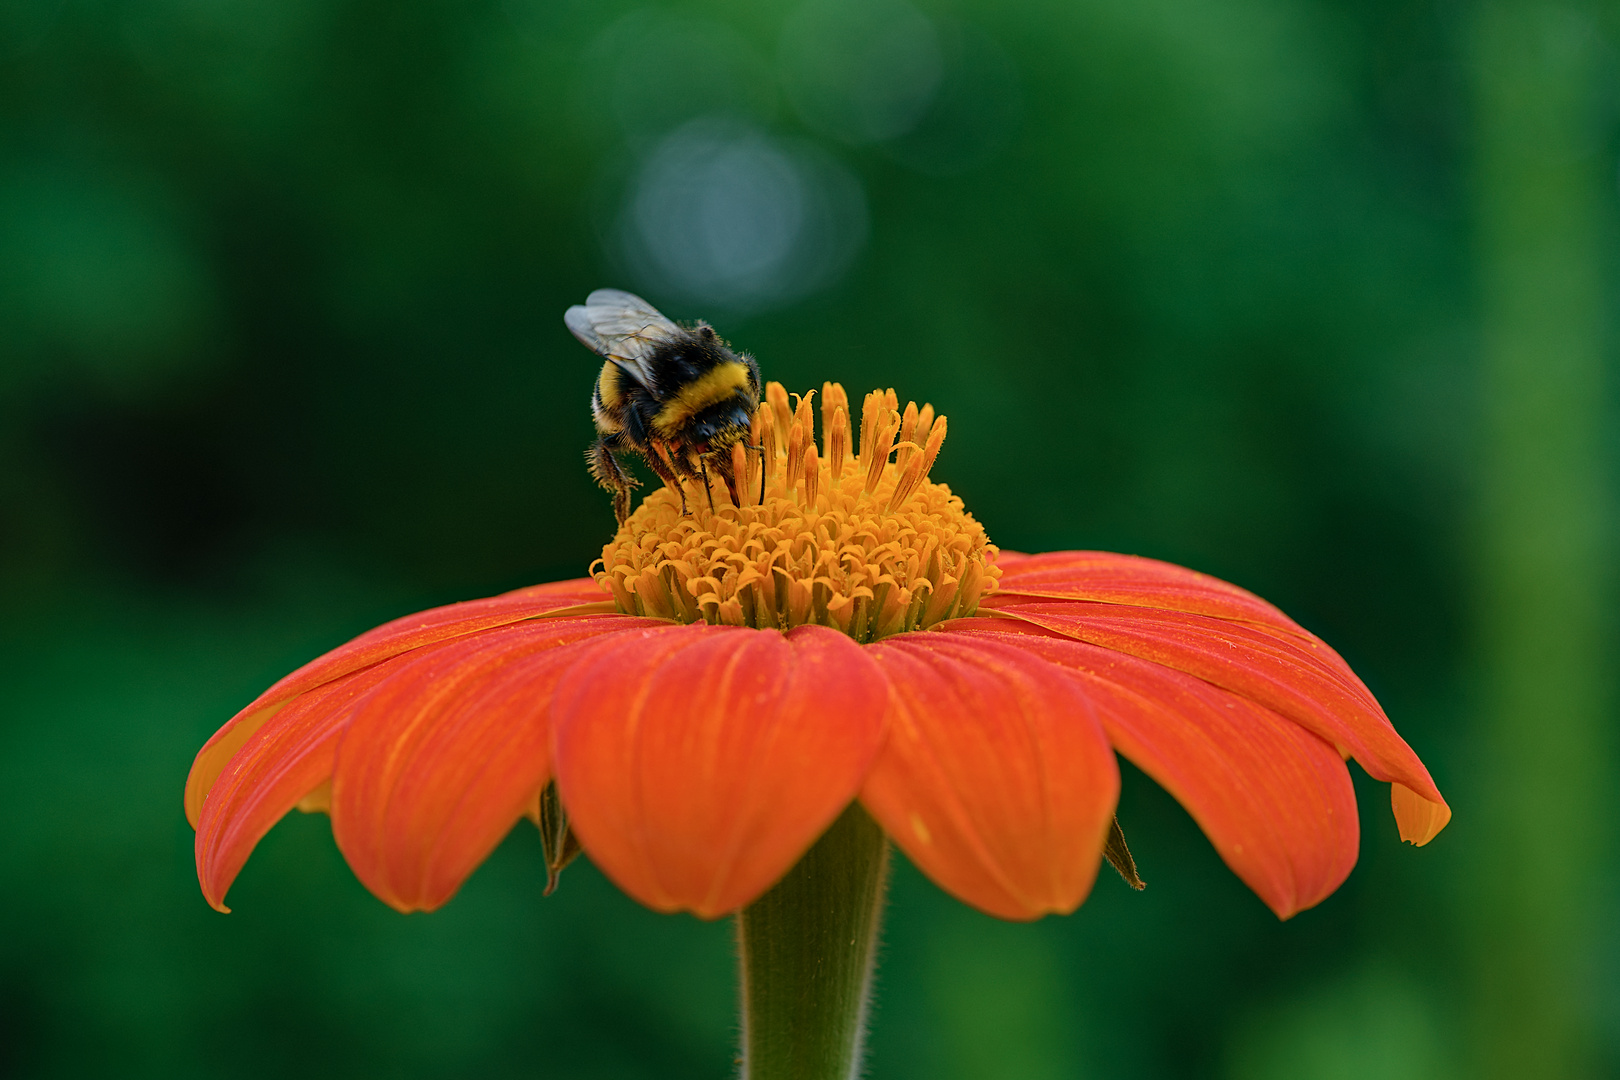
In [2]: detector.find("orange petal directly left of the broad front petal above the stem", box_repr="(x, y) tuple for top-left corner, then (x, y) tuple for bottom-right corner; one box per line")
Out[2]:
(330, 617), (648, 912)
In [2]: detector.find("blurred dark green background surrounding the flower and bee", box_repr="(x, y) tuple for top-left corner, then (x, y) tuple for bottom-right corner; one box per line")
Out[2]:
(0, 0), (1620, 1080)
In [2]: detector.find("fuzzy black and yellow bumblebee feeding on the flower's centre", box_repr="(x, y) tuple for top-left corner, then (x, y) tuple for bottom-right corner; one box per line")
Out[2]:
(562, 288), (760, 525)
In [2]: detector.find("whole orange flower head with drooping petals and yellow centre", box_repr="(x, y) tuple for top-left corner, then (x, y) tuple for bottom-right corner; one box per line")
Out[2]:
(186, 384), (1452, 920)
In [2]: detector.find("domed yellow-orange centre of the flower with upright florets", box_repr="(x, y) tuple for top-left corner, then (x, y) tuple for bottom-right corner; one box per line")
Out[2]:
(593, 382), (1001, 641)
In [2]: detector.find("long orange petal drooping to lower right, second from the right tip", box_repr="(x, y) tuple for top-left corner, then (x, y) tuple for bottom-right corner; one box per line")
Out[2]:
(946, 619), (1361, 918)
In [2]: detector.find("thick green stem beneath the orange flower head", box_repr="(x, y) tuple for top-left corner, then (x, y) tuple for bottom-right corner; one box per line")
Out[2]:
(737, 803), (889, 1080)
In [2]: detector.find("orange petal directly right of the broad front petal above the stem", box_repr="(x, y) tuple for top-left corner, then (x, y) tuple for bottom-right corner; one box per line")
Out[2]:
(860, 633), (1119, 920)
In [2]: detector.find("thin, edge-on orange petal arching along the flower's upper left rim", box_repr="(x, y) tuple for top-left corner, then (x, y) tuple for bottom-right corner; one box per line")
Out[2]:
(186, 578), (606, 827)
